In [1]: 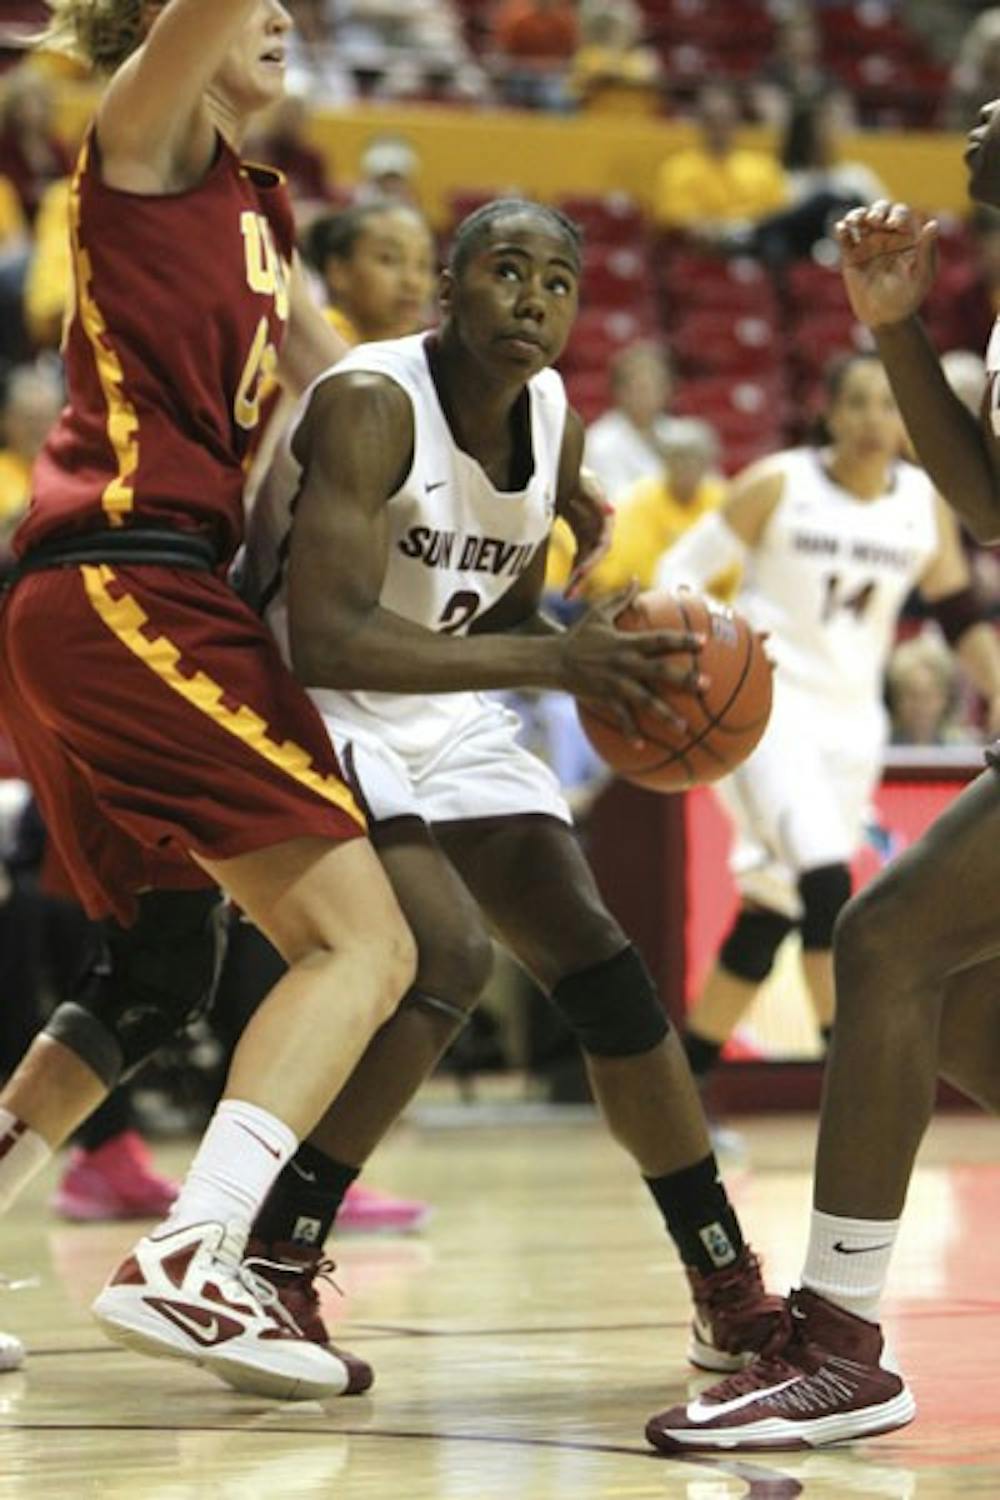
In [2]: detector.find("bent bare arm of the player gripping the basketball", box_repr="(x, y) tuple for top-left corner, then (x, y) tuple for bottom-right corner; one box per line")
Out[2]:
(289, 372), (700, 729)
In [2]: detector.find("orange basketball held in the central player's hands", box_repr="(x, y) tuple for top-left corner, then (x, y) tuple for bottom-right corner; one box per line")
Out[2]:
(577, 593), (772, 792)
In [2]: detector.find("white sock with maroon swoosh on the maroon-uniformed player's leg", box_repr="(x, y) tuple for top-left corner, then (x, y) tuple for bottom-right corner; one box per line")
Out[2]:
(162, 1100), (298, 1230)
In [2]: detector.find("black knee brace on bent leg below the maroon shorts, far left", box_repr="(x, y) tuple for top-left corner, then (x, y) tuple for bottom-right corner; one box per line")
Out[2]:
(45, 890), (225, 1088)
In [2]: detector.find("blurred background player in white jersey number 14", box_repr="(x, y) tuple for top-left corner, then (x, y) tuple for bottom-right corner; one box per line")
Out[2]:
(657, 354), (1000, 1098)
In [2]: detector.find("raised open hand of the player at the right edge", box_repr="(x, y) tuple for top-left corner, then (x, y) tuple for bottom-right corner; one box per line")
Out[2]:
(834, 198), (937, 329)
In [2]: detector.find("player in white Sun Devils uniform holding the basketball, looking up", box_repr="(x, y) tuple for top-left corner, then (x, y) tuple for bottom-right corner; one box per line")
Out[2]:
(232, 200), (775, 1370)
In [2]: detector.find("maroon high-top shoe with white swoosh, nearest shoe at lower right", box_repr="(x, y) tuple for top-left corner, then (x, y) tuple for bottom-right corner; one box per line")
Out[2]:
(646, 1290), (916, 1454)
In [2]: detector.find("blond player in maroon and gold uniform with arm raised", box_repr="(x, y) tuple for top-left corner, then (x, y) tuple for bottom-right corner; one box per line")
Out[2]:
(0, 0), (665, 1395)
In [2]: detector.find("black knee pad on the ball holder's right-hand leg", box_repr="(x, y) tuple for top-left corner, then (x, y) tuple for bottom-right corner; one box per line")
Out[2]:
(552, 945), (670, 1058)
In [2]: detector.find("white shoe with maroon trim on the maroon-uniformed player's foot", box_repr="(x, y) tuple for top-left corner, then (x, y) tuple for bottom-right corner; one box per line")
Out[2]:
(93, 1223), (364, 1401)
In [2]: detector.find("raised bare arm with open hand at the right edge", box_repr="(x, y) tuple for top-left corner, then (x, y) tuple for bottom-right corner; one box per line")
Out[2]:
(837, 201), (1000, 542)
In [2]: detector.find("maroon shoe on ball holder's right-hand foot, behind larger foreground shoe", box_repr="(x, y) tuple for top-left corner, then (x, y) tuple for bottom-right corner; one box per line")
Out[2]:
(685, 1245), (784, 1373)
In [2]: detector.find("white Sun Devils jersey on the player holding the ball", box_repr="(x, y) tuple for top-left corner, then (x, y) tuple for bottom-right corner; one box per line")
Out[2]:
(247, 333), (567, 755)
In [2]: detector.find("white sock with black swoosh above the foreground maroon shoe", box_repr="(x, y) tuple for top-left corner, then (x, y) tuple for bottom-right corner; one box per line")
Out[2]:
(802, 1209), (900, 1323)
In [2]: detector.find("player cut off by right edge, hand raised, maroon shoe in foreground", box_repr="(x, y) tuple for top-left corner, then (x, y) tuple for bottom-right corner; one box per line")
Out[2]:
(648, 101), (1000, 1452)
